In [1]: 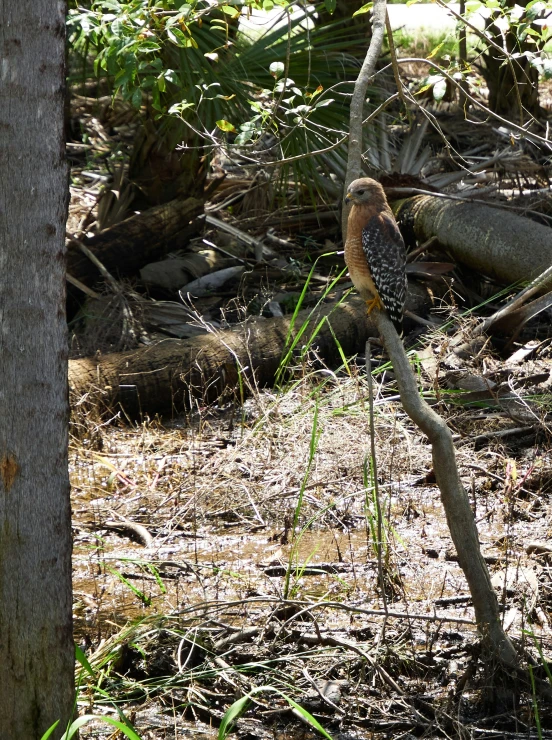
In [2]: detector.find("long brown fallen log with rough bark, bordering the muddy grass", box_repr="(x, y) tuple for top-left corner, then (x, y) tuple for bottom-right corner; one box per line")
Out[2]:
(69, 298), (375, 417)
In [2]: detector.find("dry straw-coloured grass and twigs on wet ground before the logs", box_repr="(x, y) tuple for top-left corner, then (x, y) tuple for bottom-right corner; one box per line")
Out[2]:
(71, 348), (552, 738)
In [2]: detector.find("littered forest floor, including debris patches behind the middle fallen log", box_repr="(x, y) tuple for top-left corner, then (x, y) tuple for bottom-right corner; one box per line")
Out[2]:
(64, 28), (552, 740)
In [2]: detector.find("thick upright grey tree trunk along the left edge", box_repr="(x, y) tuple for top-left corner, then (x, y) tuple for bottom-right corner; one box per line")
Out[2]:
(0, 0), (74, 740)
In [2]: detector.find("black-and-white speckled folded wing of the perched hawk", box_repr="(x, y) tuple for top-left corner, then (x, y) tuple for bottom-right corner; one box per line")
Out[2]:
(362, 213), (407, 323)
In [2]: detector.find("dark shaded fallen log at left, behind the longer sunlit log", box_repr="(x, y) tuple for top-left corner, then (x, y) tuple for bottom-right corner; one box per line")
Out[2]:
(67, 198), (204, 286)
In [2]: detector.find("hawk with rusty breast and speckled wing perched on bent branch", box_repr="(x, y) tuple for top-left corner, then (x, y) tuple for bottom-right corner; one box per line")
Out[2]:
(345, 177), (407, 332)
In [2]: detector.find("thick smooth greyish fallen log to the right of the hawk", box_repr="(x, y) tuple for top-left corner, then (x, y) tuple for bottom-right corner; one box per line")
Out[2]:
(393, 195), (552, 291)
